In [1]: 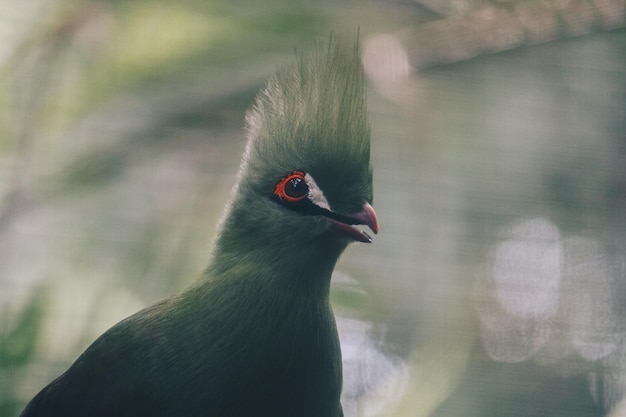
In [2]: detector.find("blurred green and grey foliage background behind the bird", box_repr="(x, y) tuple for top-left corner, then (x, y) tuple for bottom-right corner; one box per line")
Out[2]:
(0, 0), (626, 417)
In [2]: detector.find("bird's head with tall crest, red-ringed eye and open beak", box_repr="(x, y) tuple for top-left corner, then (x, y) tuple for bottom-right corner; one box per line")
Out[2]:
(219, 39), (378, 260)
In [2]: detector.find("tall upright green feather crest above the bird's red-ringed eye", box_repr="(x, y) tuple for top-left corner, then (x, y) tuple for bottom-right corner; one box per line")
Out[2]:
(240, 38), (372, 212)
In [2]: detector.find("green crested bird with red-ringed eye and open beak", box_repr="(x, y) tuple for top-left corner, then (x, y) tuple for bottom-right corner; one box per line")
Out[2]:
(21, 36), (378, 417)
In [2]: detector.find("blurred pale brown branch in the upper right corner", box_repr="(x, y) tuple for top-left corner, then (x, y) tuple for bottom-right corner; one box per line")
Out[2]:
(396, 0), (626, 69)
